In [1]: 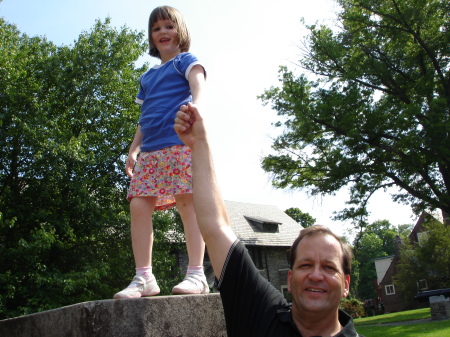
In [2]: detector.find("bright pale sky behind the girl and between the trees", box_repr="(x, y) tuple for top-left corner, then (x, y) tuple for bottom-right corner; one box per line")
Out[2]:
(0, 0), (417, 235)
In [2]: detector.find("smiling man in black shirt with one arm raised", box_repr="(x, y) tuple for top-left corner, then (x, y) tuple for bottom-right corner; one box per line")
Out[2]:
(174, 104), (359, 337)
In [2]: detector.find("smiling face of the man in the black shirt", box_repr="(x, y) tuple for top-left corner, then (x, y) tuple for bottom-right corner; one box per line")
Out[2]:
(288, 234), (350, 315)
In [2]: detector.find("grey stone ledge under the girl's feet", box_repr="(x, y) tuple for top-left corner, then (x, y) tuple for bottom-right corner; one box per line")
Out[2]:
(0, 293), (227, 337)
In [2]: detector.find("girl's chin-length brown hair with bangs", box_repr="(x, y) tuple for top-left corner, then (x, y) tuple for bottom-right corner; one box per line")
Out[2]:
(148, 6), (191, 59)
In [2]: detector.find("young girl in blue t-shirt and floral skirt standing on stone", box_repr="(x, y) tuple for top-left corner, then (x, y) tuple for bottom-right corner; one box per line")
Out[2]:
(114, 6), (209, 298)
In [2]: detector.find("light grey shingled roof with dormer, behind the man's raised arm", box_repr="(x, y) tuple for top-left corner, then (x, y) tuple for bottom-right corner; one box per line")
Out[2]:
(225, 201), (303, 247)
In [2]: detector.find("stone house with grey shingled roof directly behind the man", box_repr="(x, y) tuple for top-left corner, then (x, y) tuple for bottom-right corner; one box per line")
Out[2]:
(177, 201), (303, 300)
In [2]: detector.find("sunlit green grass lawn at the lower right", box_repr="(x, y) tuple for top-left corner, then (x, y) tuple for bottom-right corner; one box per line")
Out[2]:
(354, 308), (450, 337)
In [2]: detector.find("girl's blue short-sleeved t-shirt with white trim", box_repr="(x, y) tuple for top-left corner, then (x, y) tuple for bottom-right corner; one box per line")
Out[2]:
(136, 53), (200, 152)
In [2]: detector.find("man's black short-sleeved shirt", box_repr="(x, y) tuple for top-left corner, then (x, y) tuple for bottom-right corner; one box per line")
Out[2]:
(216, 240), (362, 337)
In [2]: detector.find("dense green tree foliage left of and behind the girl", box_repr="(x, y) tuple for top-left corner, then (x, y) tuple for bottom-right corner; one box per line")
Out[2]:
(0, 19), (183, 319)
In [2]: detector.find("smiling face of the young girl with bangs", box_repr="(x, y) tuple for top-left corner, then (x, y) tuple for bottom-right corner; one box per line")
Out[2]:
(151, 20), (181, 63)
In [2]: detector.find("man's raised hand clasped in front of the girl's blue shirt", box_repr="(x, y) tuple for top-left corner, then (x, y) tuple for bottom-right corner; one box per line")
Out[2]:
(174, 103), (206, 149)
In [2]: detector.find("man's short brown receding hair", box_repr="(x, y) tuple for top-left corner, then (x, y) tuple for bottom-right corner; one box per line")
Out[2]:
(289, 225), (352, 275)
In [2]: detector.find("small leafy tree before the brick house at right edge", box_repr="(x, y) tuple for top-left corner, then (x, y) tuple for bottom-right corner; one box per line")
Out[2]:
(394, 218), (450, 303)
